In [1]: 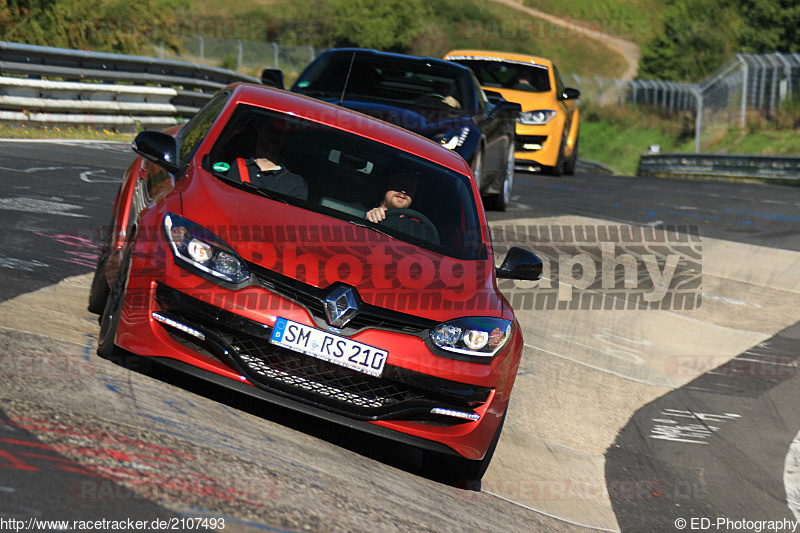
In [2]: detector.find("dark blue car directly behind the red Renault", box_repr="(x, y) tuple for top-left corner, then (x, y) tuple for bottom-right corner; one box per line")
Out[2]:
(262, 48), (520, 211)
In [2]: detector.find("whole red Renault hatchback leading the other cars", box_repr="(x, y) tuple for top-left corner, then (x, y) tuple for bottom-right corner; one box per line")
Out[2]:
(89, 84), (541, 480)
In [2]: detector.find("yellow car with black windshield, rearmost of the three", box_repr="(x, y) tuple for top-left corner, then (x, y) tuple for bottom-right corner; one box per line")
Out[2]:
(444, 50), (580, 176)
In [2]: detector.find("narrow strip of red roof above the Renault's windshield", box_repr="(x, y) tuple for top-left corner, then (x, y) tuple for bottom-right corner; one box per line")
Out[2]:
(231, 83), (470, 175)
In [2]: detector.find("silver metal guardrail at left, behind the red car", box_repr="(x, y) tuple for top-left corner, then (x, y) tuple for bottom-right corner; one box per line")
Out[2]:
(0, 41), (260, 128)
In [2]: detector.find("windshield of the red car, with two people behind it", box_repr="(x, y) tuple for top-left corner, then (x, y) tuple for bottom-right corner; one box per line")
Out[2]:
(204, 104), (485, 259)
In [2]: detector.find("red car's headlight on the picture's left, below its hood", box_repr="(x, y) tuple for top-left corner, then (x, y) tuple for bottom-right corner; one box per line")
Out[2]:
(164, 213), (250, 283)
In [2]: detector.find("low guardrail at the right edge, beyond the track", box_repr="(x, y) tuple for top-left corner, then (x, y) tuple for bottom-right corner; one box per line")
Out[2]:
(636, 153), (800, 185)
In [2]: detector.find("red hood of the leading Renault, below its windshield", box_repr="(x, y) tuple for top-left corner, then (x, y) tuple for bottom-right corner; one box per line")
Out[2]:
(181, 171), (509, 320)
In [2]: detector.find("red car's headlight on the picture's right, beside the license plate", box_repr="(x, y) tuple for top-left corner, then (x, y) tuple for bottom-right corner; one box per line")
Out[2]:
(431, 316), (511, 358)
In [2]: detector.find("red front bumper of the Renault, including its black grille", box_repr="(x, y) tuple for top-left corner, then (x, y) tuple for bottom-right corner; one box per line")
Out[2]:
(116, 232), (522, 460)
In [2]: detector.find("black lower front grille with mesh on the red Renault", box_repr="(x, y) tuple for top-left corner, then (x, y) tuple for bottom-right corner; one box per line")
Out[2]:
(156, 283), (491, 424)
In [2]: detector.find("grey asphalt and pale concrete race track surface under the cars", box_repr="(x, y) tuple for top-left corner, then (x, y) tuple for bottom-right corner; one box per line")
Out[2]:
(0, 141), (800, 532)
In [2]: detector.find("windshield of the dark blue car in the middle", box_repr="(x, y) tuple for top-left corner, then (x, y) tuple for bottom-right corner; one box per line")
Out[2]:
(292, 50), (475, 110)
